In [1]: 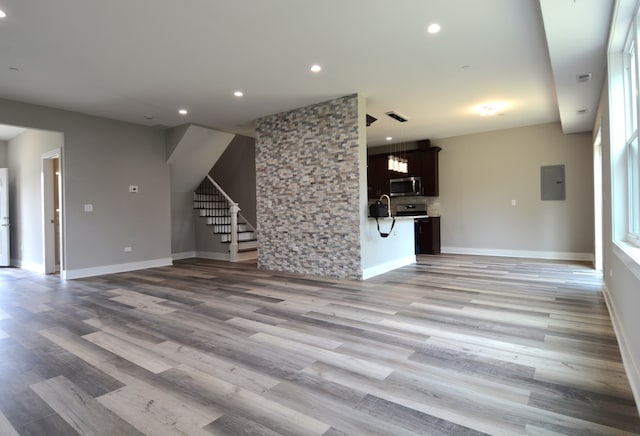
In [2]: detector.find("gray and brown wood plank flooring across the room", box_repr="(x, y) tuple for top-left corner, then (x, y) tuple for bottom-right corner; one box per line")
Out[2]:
(0, 255), (640, 436)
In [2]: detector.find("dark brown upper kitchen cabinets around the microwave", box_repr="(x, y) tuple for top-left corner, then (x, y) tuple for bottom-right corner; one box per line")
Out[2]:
(367, 147), (441, 198)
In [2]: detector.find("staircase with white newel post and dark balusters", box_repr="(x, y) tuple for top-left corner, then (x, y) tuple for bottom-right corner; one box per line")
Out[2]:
(193, 176), (258, 262)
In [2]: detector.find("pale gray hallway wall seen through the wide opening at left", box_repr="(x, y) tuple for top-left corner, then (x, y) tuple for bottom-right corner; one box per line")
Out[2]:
(8, 130), (64, 272)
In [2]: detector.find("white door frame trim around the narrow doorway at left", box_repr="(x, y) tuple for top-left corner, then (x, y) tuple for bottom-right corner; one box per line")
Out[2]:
(41, 148), (65, 277)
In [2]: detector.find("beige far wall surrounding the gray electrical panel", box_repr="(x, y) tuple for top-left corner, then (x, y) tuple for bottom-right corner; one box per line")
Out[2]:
(432, 123), (594, 259)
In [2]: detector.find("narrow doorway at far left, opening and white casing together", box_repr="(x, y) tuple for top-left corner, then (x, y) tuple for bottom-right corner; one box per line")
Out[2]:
(42, 148), (64, 274)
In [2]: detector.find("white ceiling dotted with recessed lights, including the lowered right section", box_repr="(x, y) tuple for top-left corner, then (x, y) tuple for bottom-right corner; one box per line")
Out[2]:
(0, 0), (612, 145)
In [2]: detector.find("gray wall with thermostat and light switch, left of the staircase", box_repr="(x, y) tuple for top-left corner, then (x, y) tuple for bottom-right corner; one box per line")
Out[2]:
(0, 99), (171, 273)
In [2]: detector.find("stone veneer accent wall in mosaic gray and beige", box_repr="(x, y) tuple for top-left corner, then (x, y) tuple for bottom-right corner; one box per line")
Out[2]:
(256, 95), (362, 279)
